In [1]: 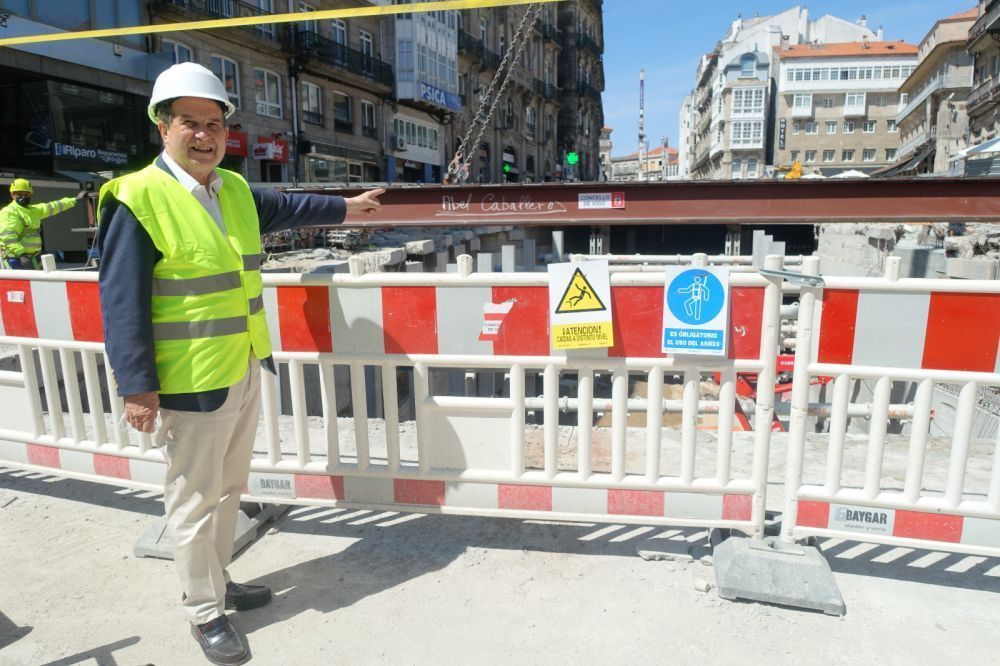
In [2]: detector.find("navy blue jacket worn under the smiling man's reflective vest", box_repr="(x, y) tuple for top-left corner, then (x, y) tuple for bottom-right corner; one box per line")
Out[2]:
(97, 159), (347, 412)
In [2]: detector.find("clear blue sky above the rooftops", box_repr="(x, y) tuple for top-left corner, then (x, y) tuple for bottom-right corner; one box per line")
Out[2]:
(603, 0), (977, 156)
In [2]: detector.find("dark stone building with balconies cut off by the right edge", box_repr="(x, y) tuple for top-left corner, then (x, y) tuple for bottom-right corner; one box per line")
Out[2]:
(965, 0), (1000, 174)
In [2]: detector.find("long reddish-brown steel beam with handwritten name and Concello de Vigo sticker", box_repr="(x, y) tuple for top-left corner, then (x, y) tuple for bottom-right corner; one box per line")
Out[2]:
(300, 178), (1000, 227)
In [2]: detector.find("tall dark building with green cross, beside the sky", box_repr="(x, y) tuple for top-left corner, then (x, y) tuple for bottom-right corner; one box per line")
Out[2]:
(557, 0), (604, 180)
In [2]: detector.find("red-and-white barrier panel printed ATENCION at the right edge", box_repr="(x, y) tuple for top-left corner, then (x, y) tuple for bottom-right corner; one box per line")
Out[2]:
(782, 258), (1000, 557)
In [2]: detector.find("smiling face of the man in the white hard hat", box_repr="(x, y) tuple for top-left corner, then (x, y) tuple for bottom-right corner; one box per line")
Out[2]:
(157, 97), (228, 186)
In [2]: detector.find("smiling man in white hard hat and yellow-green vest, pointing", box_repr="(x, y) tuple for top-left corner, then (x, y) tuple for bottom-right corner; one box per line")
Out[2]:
(97, 63), (384, 664)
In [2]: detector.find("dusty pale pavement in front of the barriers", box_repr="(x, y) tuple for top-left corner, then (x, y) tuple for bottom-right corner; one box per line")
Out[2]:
(0, 470), (1000, 666)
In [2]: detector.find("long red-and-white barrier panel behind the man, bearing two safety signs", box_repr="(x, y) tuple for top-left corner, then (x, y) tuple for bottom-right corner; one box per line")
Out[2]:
(0, 257), (781, 535)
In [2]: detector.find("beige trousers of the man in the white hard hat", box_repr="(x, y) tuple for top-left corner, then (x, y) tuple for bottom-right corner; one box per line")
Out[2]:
(160, 358), (260, 624)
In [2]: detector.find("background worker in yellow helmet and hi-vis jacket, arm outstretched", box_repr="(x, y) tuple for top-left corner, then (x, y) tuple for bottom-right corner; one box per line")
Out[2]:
(0, 178), (87, 269)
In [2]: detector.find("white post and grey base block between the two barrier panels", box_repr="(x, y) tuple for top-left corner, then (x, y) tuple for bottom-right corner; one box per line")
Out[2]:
(713, 257), (847, 615)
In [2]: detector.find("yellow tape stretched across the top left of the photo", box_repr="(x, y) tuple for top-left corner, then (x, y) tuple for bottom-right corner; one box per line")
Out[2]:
(0, 0), (563, 46)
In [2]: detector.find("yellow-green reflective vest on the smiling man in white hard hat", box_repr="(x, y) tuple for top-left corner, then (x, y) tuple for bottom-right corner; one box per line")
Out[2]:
(98, 164), (271, 394)
